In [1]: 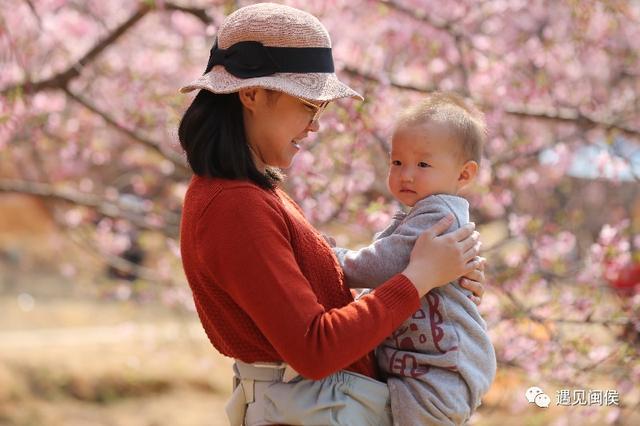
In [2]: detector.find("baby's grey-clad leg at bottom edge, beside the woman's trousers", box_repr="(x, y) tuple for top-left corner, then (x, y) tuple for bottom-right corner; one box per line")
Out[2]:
(387, 367), (472, 426)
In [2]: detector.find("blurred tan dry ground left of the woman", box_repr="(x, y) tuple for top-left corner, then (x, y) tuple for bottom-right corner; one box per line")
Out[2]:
(0, 298), (231, 426)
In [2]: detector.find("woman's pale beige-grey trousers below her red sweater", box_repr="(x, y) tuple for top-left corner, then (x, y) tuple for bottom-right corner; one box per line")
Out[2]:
(227, 361), (392, 426)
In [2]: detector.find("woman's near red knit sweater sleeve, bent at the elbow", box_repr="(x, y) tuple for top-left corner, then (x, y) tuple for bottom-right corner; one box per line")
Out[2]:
(197, 188), (420, 379)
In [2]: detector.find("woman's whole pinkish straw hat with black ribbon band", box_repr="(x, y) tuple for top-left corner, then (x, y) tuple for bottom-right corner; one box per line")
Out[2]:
(180, 3), (363, 101)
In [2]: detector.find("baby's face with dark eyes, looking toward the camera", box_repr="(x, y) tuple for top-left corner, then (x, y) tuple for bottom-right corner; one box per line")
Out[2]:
(389, 123), (463, 206)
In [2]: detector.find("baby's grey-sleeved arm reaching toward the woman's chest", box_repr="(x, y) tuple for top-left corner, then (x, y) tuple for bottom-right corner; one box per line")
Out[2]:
(333, 203), (458, 288)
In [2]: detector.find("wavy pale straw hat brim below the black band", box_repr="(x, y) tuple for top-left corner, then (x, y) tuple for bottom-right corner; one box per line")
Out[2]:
(180, 65), (364, 101)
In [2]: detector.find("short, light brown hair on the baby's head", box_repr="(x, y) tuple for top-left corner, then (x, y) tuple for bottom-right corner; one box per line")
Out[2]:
(396, 92), (487, 164)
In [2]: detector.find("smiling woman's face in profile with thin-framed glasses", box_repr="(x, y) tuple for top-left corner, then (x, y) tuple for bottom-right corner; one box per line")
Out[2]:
(239, 88), (320, 171)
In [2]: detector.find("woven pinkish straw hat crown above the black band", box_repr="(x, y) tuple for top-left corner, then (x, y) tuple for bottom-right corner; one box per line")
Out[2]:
(218, 3), (331, 49)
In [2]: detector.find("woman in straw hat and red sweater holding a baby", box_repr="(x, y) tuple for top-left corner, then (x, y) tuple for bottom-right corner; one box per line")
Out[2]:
(179, 3), (484, 425)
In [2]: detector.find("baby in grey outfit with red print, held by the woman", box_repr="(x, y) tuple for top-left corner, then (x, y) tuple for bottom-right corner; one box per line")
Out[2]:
(334, 93), (496, 426)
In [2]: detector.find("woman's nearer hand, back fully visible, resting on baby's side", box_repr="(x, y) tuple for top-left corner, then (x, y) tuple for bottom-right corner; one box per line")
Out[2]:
(402, 215), (482, 297)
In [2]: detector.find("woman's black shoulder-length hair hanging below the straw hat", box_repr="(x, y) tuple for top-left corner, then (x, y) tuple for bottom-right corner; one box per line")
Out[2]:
(178, 90), (282, 189)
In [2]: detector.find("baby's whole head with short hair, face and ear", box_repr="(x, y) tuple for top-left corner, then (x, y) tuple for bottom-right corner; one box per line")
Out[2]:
(389, 92), (486, 206)
